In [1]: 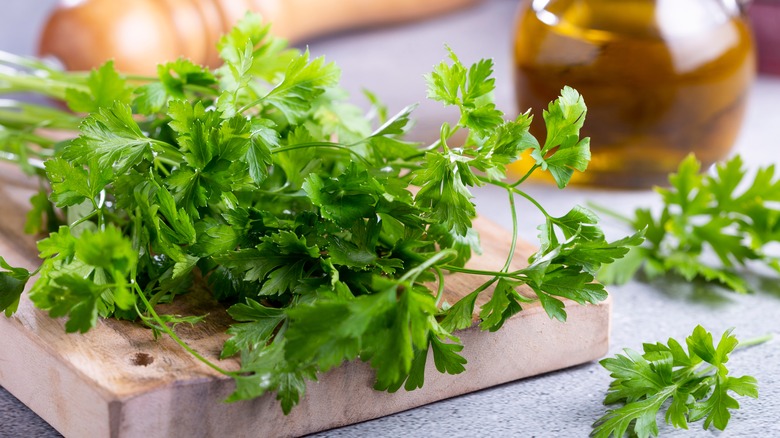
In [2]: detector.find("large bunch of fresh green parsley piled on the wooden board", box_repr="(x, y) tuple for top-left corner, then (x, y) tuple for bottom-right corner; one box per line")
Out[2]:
(0, 15), (641, 412)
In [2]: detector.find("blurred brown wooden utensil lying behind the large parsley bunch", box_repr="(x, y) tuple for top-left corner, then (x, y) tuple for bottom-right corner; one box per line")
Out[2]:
(39, 0), (479, 74)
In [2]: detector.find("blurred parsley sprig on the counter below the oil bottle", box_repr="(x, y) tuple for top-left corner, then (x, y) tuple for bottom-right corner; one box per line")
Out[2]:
(599, 155), (780, 293)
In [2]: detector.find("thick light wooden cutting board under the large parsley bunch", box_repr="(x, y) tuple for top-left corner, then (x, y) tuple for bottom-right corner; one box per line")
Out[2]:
(0, 166), (611, 438)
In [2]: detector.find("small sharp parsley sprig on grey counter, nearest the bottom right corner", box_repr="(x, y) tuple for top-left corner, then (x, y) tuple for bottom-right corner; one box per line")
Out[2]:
(591, 326), (765, 438)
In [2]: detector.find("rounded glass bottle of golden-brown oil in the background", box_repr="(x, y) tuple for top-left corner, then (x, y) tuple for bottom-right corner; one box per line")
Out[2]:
(510, 0), (755, 188)
